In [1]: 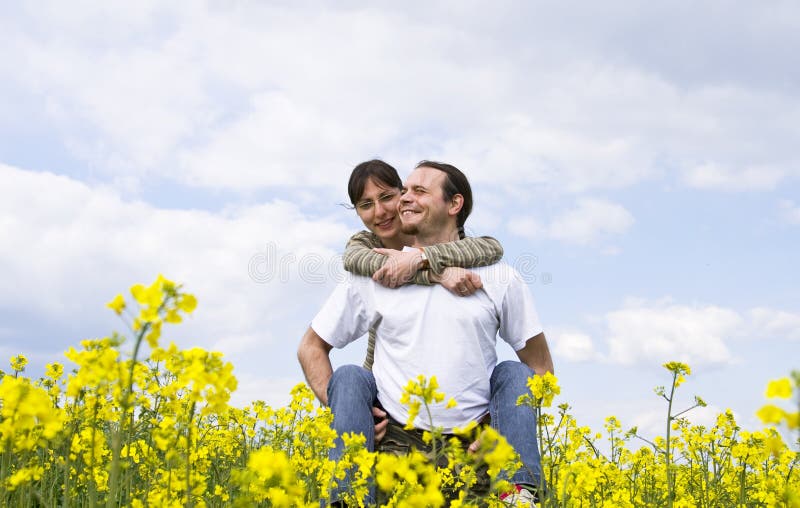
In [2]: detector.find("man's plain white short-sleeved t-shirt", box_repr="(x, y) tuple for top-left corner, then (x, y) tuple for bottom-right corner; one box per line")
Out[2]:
(311, 262), (542, 432)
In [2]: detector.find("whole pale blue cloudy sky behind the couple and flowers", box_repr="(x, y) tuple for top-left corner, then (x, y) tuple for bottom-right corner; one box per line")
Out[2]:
(0, 0), (800, 436)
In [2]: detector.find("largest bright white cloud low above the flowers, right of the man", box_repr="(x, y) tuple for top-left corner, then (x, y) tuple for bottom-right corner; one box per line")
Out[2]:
(606, 300), (744, 365)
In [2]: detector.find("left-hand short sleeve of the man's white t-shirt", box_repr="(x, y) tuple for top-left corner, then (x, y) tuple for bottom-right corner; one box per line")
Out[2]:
(311, 279), (370, 348)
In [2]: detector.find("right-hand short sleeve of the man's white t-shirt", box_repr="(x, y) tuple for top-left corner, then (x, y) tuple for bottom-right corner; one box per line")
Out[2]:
(499, 270), (542, 351)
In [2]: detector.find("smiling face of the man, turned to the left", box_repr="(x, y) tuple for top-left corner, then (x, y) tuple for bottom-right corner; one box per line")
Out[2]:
(400, 166), (450, 235)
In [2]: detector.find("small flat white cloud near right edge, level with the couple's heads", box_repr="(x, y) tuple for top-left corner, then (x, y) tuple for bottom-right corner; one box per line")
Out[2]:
(683, 163), (786, 191)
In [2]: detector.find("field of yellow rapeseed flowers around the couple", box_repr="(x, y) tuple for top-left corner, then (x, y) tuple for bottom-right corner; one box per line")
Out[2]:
(0, 276), (800, 507)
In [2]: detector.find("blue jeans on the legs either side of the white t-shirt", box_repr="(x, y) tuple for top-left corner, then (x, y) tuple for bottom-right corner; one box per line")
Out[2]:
(328, 361), (541, 502)
